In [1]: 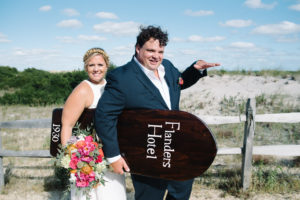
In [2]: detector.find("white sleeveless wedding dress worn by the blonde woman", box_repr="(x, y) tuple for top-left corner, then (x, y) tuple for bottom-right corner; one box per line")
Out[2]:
(71, 80), (126, 200)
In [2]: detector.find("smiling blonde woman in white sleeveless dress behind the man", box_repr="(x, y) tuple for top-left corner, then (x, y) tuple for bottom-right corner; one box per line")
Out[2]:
(61, 48), (126, 200)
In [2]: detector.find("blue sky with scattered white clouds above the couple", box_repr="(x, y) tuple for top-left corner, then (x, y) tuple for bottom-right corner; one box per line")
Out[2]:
(0, 0), (300, 71)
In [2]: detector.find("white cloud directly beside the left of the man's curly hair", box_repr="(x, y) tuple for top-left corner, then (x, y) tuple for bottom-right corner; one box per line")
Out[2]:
(94, 21), (140, 35)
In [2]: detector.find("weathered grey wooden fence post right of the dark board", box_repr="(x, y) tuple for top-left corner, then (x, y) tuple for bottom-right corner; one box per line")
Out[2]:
(242, 99), (256, 190)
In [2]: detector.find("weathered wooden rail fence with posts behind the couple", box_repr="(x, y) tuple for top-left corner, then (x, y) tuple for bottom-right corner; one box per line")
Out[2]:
(0, 99), (300, 191)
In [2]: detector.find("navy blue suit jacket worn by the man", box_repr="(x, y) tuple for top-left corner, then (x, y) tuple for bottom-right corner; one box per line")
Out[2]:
(95, 56), (207, 158)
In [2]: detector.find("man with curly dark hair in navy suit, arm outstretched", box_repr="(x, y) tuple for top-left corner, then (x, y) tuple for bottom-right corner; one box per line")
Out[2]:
(95, 26), (219, 200)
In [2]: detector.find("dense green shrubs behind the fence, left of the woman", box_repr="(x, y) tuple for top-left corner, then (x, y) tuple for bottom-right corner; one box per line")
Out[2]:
(0, 67), (87, 106)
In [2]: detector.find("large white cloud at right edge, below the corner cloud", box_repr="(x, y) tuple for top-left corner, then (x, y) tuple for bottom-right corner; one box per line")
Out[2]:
(252, 21), (300, 35)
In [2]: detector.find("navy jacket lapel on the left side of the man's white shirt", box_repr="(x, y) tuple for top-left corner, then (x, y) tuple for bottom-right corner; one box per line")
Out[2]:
(131, 59), (168, 109)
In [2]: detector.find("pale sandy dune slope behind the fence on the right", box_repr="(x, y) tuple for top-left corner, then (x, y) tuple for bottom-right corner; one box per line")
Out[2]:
(181, 75), (300, 115)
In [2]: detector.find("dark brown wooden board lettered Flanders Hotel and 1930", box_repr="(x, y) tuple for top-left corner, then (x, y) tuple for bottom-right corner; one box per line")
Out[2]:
(50, 109), (217, 180)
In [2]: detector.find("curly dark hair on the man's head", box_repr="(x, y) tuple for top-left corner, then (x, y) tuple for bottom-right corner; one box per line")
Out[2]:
(135, 26), (168, 47)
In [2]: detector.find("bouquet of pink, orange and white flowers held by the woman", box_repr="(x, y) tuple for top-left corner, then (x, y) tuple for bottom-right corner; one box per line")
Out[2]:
(56, 134), (106, 195)
